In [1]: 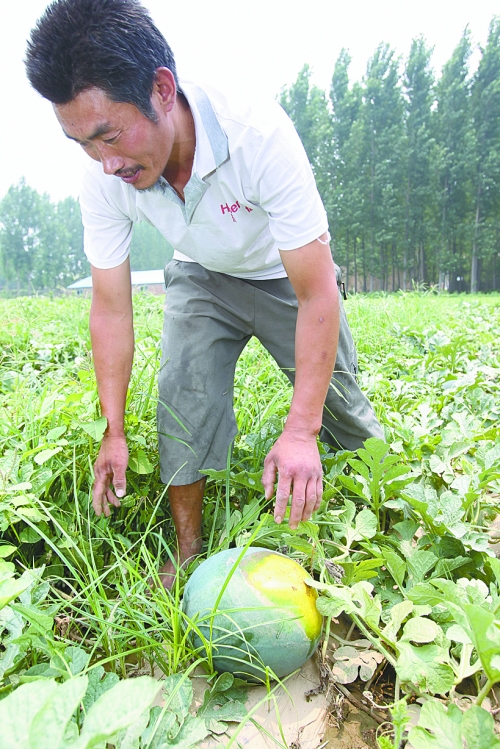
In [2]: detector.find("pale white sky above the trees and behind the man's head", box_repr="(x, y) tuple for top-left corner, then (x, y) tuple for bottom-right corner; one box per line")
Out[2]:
(0, 0), (500, 201)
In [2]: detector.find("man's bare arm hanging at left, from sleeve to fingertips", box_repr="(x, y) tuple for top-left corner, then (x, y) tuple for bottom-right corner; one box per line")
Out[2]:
(90, 259), (134, 517)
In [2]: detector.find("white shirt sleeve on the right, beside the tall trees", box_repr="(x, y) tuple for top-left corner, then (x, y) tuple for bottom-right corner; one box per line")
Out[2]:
(251, 104), (328, 250)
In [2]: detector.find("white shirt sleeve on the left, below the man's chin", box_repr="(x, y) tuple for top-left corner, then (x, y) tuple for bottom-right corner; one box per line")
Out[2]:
(80, 164), (133, 269)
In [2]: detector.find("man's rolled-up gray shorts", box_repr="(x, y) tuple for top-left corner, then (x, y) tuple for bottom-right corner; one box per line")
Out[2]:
(157, 260), (383, 486)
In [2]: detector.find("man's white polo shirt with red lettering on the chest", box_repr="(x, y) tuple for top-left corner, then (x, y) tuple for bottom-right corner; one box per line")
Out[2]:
(80, 81), (328, 280)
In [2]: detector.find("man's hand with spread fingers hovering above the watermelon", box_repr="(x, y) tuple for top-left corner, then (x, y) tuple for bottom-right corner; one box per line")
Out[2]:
(262, 427), (323, 530)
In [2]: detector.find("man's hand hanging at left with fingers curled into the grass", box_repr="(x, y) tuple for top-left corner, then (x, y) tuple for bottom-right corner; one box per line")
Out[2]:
(92, 434), (128, 518)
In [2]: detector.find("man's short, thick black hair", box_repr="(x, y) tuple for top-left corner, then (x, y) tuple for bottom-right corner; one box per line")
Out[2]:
(25, 0), (178, 121)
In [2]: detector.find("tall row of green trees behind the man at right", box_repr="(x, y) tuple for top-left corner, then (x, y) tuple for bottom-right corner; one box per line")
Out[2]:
(280, 18), (500, 291)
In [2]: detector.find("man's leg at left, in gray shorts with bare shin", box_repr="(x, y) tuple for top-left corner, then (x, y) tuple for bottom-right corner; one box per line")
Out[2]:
(157, 261), (254, 587)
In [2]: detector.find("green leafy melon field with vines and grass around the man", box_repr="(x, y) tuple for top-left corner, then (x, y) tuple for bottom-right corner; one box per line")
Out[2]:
(0, 291), (500, 749)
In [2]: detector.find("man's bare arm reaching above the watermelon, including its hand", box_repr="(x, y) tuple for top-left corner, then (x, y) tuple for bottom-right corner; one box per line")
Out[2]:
(262, 235), (339, 528)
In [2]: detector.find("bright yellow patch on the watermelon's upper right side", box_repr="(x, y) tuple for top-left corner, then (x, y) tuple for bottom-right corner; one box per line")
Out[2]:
(242, 552), (323, 640)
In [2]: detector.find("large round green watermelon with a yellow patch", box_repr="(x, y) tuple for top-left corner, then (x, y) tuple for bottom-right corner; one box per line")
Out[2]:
(183, 546), (322, 681)
